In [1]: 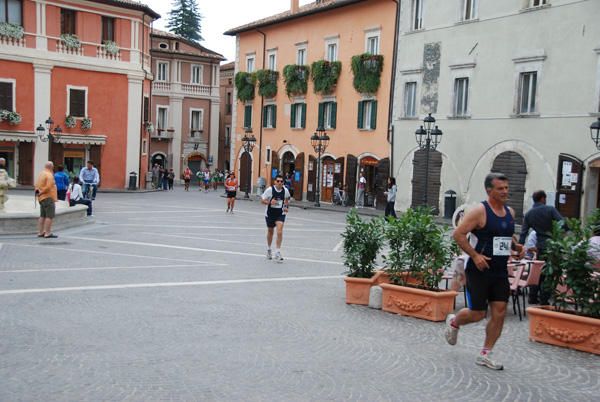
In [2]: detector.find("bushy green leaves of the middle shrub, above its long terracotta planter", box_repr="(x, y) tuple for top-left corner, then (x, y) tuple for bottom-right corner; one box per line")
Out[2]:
(383, 206), (457, 290)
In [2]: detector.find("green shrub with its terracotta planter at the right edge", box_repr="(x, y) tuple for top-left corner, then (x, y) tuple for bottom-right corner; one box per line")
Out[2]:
(527, 209), (600, 354)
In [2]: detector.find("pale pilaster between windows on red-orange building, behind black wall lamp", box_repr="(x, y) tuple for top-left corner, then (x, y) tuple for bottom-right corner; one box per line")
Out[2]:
(33, 64), (52, 174)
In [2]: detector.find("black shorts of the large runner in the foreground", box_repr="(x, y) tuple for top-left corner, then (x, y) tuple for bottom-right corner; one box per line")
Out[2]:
(465, 268), (510, 311)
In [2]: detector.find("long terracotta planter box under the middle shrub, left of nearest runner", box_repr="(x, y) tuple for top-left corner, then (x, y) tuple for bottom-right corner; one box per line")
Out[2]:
(380, 283), (458, 321)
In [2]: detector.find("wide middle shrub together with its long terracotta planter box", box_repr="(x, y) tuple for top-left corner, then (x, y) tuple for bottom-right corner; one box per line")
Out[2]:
(380, 206), (458, 321)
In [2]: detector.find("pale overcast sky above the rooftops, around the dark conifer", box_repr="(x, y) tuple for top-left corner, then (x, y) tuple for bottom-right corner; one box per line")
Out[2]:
(141, 0), (314, 62)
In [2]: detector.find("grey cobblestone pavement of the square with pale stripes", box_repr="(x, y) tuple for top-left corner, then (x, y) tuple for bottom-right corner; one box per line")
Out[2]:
(0, 188), (600, 401)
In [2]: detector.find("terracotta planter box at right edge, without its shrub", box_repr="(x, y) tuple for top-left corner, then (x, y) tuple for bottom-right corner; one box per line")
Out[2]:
(526, 306), (600, 355)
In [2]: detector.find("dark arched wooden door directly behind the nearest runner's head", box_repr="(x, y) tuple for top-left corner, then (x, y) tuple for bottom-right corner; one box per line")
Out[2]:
(492, 151), (527, 224)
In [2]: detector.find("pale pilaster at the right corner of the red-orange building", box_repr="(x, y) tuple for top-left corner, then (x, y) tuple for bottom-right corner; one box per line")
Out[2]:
(123, 75), (145, 188)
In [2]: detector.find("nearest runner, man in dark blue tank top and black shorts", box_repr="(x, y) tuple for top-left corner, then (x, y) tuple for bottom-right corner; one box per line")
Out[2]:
(445, 173), (525, 370)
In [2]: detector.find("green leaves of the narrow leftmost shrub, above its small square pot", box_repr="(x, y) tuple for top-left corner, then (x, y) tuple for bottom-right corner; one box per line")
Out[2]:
(342, 208), (384, 278)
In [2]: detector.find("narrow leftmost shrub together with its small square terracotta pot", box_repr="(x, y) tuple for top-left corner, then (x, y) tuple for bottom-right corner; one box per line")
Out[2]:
(342, 208), (384, 305)
